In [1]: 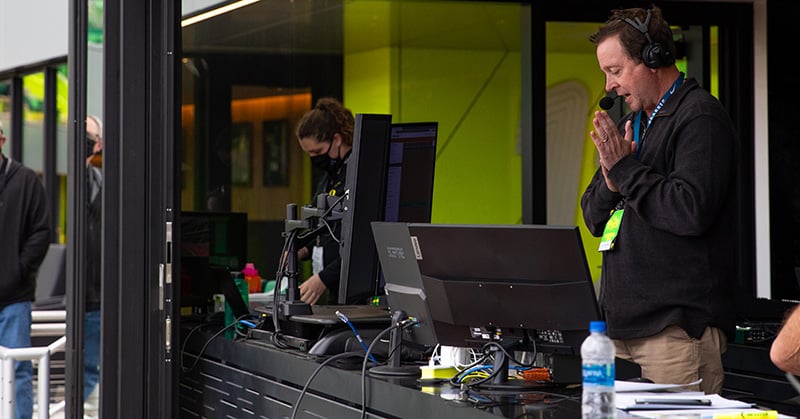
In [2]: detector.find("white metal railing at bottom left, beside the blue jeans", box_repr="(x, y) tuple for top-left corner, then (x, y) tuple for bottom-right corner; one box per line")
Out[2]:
(0, 310), (67, 419)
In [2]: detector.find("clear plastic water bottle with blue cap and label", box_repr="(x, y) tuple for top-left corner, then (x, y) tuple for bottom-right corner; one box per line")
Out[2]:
(581, 321), (617, 419)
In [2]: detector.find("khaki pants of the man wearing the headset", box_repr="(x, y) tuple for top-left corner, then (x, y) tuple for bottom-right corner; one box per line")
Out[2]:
(614, 326), (727, 394)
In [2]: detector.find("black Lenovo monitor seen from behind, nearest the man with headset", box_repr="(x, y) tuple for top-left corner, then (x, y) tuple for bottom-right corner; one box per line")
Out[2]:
(408, 224), (600, 355)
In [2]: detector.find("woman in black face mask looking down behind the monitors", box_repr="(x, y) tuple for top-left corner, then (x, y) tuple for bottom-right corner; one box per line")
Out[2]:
(295, 98), (355, 304)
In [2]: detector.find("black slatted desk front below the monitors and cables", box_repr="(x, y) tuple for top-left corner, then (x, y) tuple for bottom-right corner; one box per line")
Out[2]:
(179, 328), (640, 419)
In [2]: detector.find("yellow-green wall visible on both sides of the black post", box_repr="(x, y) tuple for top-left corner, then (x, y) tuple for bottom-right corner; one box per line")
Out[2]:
(344, 2), (616, 284)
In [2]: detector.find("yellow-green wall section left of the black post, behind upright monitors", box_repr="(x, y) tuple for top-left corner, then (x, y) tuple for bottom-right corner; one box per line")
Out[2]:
(344, 48), (522, 224)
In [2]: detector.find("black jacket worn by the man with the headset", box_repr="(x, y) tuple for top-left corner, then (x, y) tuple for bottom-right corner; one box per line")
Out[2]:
(581, 79), (738, 339)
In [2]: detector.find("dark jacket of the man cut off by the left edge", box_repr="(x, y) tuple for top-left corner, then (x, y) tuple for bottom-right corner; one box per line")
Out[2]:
(0, 156), (51, 308)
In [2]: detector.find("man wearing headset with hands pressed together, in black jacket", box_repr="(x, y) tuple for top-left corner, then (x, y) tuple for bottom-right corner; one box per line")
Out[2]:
(581, 7), (738, 393)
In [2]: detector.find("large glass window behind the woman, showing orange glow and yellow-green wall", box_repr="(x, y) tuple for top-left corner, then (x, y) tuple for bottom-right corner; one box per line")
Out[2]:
(181, 0), (530, 292)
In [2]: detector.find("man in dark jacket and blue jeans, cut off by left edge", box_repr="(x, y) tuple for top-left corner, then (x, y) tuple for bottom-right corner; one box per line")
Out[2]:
(0, 120), (51, 419)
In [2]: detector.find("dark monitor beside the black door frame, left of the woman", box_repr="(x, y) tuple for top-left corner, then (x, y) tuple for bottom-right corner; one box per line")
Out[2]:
(178, 211), (247, 314)
